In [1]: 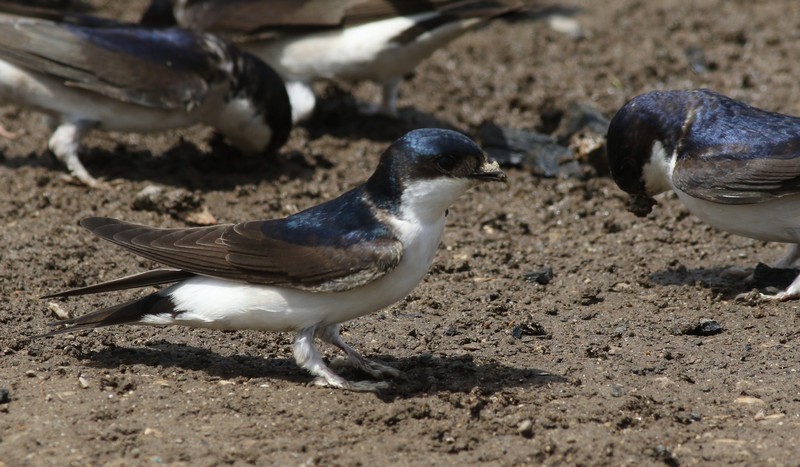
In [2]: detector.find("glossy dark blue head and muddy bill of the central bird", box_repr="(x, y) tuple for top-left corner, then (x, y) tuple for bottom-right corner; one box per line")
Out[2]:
(366, 128), (506, 212)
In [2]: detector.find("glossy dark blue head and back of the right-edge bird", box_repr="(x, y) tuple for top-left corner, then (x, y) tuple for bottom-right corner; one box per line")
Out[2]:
(607, 89), (800, 216)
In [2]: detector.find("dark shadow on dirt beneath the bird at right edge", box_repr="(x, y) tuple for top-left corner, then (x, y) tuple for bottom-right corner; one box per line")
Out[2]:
(650, 263), (798, 300)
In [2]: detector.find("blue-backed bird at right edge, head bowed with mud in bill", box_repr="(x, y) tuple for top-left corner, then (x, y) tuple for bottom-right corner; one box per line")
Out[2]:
(607, 89), (800, 300)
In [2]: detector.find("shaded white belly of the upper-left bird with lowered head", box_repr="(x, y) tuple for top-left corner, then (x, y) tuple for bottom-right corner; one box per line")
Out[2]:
(0, 60), (202, 132)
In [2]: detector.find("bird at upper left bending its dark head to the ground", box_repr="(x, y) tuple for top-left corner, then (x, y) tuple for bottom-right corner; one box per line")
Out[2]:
(0, 4), (291, 186)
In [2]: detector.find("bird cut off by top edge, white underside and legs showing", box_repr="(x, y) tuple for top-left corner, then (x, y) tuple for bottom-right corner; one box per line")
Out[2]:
(142, 0), (523, 122)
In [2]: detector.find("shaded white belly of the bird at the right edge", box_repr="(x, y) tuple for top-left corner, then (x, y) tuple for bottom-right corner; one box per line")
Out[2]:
(675, 190), (800, 243)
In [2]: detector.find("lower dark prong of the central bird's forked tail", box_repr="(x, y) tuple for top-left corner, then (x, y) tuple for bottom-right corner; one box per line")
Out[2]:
(36, 292), (176, 337)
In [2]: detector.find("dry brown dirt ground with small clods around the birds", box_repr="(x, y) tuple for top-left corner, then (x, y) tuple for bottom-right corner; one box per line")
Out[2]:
(0, 0), (800, 466)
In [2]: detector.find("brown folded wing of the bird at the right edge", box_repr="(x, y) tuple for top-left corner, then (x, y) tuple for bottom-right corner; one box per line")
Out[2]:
(672, 148), (800, 204)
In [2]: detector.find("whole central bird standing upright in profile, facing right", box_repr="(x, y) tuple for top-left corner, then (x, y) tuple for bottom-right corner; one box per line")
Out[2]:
(42, 129), (506, 390)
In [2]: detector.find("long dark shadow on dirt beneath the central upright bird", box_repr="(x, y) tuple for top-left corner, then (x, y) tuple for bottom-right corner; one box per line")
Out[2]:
(78, 341), (568, 401)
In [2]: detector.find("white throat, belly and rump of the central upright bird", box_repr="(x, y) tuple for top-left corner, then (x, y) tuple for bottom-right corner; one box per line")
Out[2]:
(159, 216), (444, 331)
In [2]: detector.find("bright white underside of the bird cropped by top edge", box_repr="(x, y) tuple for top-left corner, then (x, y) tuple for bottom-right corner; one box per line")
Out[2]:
(241, 13), (480, 82)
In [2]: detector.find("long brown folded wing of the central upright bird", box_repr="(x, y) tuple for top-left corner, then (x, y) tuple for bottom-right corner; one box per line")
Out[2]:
(81, 217), (403, 292)
